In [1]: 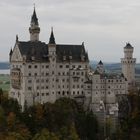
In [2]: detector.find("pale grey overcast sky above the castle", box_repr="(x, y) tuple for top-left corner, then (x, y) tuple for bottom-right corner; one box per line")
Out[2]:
(0, 0), (140, 62)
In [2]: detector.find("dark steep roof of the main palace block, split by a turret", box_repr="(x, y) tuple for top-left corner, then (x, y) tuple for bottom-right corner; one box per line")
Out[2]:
(18, 41), (88, 62)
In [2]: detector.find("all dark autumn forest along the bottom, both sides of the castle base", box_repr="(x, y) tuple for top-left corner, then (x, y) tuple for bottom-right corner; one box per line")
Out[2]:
(0, 89), (140, 140)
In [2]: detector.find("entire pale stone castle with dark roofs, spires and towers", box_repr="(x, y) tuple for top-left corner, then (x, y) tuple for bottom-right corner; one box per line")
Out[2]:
(9, 9), (136, 131)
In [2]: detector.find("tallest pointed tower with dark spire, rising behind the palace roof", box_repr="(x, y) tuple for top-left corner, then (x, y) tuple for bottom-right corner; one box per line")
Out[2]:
(29, 5), (40, 41)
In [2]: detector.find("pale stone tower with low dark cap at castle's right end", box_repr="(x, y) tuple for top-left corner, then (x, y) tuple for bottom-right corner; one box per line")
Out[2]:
(121, 43), (136, 84)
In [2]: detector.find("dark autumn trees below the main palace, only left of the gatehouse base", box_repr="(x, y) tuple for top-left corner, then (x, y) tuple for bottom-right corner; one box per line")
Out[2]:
(0, 89), (98, 140)
